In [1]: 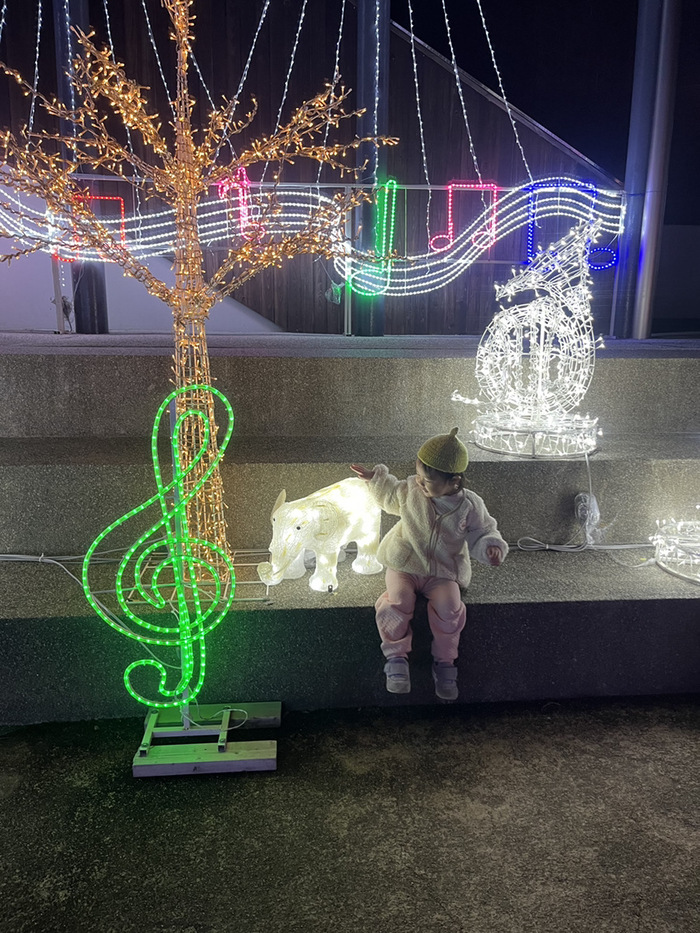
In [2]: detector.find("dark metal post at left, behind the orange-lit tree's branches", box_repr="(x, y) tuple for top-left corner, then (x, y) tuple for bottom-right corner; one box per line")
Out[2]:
(53, 0), (109, 334)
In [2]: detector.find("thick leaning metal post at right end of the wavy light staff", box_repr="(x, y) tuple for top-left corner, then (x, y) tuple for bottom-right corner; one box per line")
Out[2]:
(610, 0), (680, 337)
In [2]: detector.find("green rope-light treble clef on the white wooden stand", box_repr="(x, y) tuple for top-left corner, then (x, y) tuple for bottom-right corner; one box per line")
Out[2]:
(83, 385), (235, 708)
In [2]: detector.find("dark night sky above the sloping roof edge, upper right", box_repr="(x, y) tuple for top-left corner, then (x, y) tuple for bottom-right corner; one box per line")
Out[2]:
(391, 0), (700, 224)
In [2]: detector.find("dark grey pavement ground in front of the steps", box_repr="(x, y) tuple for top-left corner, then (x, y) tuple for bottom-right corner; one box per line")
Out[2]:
(0, 697), (700, 933)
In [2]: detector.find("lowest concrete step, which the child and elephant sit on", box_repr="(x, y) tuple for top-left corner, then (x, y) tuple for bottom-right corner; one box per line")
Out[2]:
(0, 550), (700, 723)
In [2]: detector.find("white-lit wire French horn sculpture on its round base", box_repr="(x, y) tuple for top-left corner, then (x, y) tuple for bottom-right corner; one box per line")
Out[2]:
(460, 225), (598, 458)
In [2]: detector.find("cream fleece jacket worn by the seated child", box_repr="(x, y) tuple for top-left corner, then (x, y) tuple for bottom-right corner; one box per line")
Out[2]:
(369, 463), (508, 587)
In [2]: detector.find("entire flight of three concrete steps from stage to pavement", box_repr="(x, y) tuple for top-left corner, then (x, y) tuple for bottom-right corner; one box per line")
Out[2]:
(0, 335), (700, 722)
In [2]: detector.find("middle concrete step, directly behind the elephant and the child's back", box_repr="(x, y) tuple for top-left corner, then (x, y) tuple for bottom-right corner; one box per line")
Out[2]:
(0, 434), (700, 554)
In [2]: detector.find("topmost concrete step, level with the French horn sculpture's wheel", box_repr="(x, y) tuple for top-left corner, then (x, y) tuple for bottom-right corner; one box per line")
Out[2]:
(0, 335), (700, 440)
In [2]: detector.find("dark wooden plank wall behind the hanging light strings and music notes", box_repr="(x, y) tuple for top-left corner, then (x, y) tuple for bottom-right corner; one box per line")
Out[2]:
(0, 0), (614, 334)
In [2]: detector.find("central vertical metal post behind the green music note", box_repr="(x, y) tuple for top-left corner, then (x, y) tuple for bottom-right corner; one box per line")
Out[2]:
(354, 0), (390, 336)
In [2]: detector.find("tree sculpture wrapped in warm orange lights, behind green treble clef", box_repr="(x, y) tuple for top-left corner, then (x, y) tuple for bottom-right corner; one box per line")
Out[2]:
(0, 0), (394, 588)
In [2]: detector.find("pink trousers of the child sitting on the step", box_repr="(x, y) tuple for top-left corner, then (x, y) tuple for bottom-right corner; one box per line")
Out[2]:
(374, 568), (467, 661)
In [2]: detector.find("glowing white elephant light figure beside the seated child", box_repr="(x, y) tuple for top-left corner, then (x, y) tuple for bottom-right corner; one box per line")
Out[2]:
(258, 478), (382, 593)
